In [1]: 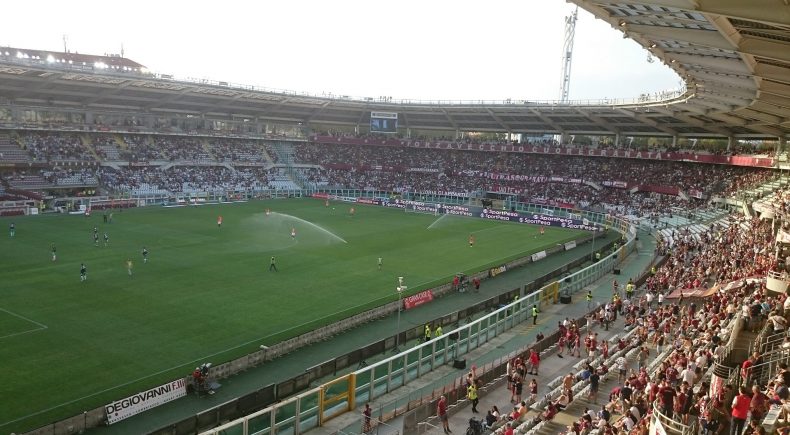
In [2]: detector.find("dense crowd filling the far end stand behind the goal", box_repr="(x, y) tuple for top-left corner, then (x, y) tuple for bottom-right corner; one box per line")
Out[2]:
(295, 144), (772, 216)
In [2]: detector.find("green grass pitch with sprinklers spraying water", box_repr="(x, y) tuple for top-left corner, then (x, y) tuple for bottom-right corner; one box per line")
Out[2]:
(0, 199), (581, 433)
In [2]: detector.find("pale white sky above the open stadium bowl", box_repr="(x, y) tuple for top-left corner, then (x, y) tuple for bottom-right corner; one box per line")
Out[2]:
(0, 0), (679, 101)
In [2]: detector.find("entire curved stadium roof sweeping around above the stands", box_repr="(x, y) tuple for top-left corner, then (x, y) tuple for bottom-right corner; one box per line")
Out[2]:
(0, 0), (790, 138)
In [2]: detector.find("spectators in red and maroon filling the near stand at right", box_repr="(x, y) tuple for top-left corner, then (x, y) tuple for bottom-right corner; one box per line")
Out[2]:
(474, 209), (790, 435)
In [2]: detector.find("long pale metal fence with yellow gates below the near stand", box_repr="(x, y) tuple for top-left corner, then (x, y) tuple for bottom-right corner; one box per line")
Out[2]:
(198, 216), (636, 435)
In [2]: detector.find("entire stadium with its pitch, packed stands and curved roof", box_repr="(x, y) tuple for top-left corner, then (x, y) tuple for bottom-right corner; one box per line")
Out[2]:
(0, 0), (790, 435)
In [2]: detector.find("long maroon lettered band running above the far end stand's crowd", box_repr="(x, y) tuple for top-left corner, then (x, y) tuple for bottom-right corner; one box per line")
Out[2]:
(310, 136), (774, 168)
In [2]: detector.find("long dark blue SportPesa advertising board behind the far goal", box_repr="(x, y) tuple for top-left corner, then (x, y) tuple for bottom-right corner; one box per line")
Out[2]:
(313, 193), (603, 231)
